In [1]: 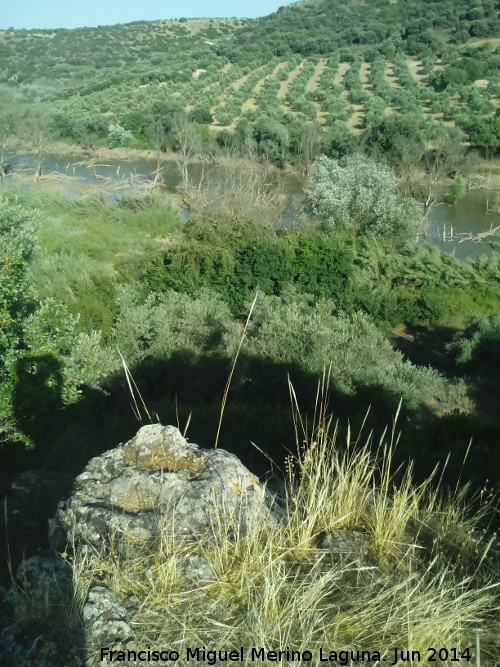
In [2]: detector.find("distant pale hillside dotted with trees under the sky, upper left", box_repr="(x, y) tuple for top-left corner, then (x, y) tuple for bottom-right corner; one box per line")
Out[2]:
(0, 19), (247, 88)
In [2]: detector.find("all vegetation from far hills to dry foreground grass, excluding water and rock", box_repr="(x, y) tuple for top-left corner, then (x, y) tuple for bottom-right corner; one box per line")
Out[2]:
(0, 0), (500, 665)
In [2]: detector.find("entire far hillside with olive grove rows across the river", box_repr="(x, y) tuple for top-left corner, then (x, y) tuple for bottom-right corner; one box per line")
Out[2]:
(0, 0), (500, 161)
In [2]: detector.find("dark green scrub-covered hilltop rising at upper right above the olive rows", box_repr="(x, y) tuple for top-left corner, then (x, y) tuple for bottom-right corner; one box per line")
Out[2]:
(219, 0), (500, 58)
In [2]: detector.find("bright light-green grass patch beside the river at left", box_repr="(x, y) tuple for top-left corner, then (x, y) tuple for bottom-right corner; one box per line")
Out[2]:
(6, 190), (183, 334)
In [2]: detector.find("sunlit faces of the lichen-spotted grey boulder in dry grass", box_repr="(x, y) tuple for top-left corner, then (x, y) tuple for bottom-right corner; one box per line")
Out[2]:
(45, 424), (276, 664)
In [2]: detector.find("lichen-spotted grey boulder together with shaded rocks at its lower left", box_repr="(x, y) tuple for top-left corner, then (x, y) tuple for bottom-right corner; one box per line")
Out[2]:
(0, 424), (276, 667)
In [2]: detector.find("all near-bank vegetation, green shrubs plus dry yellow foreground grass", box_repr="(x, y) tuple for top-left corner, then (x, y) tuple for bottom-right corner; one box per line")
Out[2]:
(0, 183), (500, 665)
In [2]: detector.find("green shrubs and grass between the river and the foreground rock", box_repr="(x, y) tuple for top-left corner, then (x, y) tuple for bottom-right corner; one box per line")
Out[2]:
(1, 183), (500, 490)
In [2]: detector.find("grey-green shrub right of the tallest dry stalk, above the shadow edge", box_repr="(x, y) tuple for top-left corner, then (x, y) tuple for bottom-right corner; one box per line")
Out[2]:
(246, 289), (441, 408)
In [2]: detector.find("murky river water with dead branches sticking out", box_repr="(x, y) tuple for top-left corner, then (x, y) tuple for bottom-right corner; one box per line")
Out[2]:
(6, 154), (500, 259)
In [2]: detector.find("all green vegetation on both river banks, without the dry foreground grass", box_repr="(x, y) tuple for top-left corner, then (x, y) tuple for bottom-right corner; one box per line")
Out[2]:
(0, 0), (500, 528)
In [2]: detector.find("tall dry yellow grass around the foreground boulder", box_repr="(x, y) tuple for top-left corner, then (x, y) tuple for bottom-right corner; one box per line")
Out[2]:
(48, 374), (498, 667)
